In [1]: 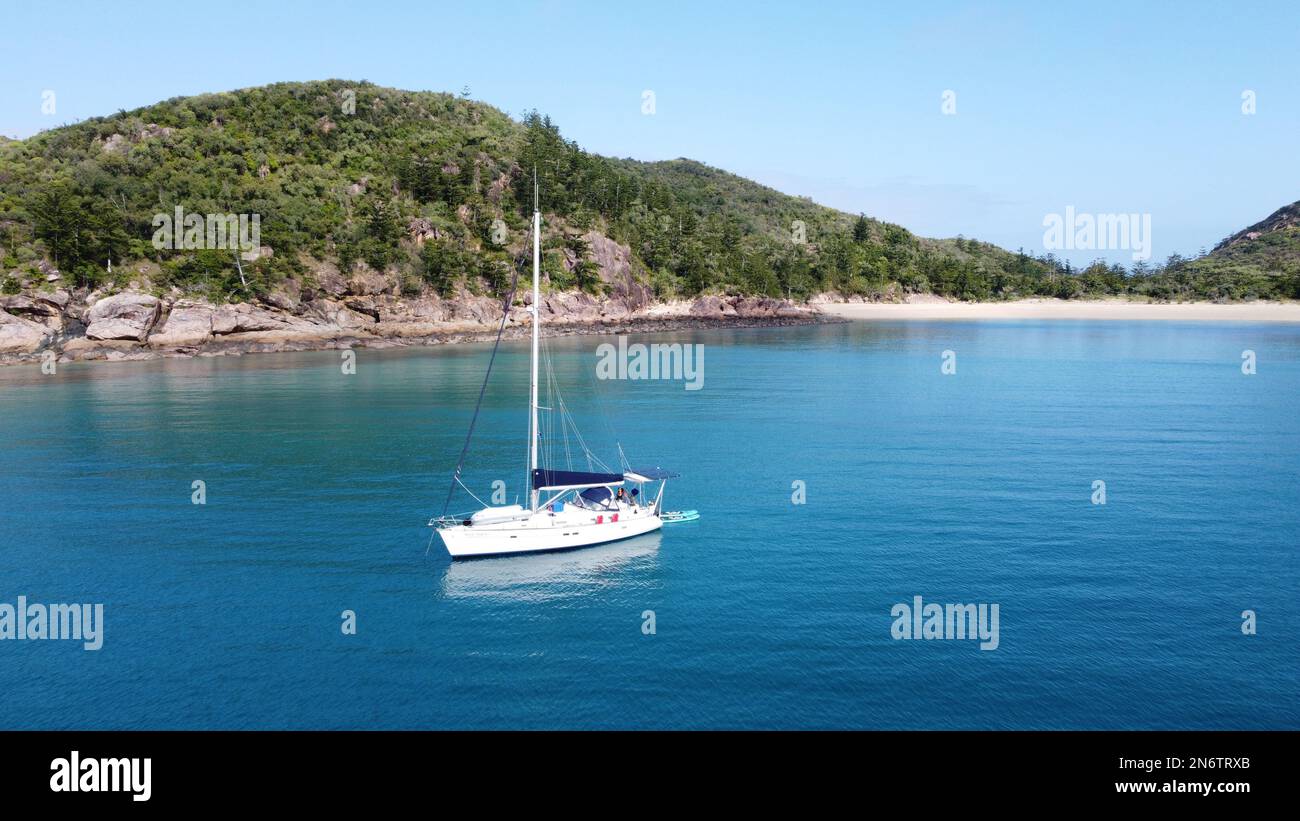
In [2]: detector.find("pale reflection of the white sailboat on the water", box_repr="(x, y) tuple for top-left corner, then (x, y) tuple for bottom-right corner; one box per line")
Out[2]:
(442, 530), (663, 601)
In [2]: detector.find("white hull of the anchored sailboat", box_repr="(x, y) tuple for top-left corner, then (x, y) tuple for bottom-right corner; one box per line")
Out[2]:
(438, 505), (663, 559)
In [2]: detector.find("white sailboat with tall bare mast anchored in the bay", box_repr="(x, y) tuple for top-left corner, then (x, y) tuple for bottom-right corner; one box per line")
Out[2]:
(429, 173), (698, 559)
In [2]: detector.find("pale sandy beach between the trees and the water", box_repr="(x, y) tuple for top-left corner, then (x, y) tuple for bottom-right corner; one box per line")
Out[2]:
(818, 297), (1300, 322)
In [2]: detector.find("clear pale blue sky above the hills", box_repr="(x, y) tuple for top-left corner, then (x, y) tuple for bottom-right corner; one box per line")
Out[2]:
(0, 0), (1300, 264)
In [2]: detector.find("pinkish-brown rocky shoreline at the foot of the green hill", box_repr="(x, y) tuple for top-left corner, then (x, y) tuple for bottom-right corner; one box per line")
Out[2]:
(0, 285), (842, 365)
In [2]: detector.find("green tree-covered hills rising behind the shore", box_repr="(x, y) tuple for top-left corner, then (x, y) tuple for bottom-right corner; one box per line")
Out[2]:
(0, 81), (1297, 299)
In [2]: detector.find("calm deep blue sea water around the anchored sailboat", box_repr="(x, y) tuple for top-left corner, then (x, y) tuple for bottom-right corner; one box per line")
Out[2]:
(0, 322), (1300, 729)
